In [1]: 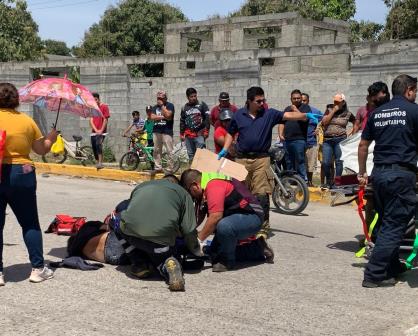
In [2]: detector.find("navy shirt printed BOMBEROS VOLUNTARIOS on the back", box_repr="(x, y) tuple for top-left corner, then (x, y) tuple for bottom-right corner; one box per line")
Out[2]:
(361, 96), (418, 167)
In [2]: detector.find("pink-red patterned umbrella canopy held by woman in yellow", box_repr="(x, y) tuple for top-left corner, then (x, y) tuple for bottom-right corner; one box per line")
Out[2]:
(19, 76), (102, 120)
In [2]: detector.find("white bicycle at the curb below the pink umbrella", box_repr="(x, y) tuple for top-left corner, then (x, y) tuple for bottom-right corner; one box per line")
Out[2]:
(42, 135), (96, 166)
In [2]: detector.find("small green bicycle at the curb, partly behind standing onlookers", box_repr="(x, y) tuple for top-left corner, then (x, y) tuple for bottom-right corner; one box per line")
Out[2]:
(119, 135), (180, 174)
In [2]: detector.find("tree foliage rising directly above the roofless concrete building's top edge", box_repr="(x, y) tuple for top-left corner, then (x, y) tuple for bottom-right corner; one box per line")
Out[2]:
(232, 0), (356, 20)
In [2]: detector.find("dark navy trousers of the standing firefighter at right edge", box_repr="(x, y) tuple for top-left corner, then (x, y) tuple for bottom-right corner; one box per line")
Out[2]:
(364, 166), (416, 281)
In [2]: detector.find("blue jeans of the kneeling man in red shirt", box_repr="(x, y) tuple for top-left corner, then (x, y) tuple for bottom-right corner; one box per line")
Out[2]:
(211, 214), (262, 266)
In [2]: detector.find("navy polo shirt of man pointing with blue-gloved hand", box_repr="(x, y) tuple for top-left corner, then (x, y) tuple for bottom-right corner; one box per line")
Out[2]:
(228, 107), (284, 153)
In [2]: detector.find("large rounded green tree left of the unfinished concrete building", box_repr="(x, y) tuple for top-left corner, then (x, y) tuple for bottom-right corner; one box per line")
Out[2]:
(73, 0), (187, 57)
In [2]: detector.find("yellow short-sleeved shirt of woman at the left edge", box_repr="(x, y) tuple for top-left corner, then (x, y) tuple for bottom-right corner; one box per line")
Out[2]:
(0, 108), (43, 164)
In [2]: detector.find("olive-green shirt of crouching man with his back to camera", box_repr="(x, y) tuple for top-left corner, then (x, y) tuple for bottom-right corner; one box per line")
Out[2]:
(120, 180), (198, 251)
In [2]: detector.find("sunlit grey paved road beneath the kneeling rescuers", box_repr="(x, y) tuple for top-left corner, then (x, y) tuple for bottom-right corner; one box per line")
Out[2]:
(0, 176), (418, 336)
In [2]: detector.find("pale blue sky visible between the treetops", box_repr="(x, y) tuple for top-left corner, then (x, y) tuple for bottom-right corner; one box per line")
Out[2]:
(27, 0), (387, 47)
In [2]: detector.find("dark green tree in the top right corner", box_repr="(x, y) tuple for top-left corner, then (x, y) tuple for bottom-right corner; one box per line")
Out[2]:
(382, 0), (418, 39)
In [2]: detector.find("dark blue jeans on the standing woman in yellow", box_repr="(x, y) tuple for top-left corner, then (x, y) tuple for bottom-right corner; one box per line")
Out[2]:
(0, 164), (44, 271)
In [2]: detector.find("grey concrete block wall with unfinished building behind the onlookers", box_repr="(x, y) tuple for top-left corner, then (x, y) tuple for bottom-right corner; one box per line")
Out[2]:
(0, 13), (418, 158)
